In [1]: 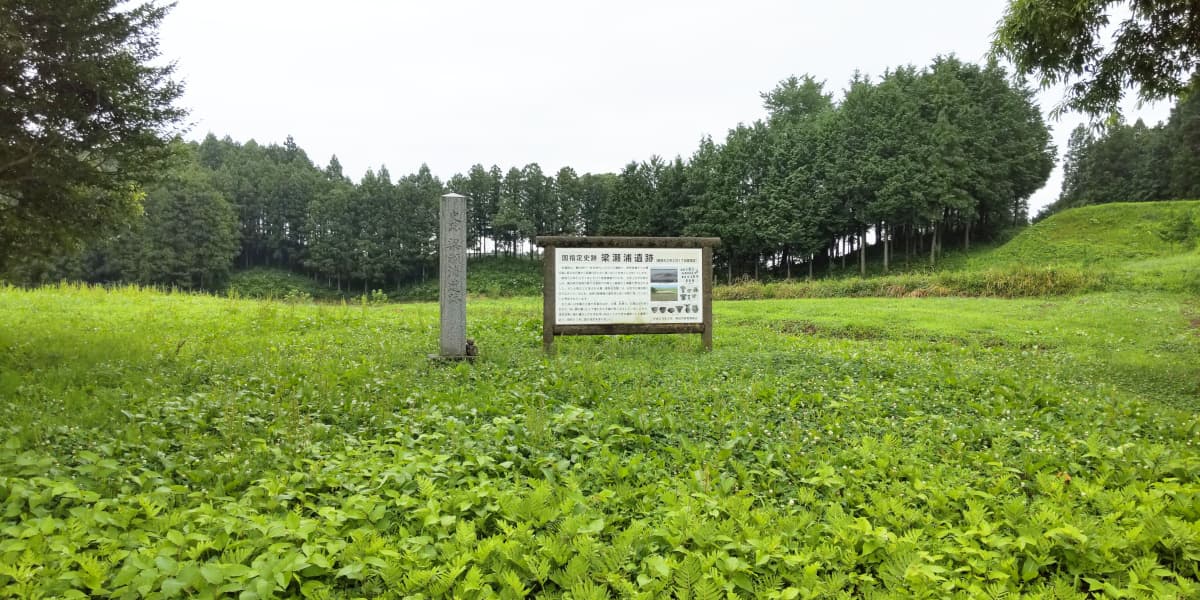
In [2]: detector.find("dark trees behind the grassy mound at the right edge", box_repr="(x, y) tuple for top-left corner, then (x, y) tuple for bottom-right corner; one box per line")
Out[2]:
(1038, 85), (1200, 218)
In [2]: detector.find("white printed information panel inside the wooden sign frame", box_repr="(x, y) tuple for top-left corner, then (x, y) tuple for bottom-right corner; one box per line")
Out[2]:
(554, 247), (703, 325)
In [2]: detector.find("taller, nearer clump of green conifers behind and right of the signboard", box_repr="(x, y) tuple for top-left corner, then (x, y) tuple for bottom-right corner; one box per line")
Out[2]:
(648, 58), (1054, 276)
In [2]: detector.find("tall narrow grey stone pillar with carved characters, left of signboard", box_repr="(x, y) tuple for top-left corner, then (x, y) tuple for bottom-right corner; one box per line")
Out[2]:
(438, 193), (475, 360)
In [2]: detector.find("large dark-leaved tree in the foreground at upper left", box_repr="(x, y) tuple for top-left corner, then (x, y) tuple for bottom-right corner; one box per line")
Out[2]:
(0, 0), (185, 269)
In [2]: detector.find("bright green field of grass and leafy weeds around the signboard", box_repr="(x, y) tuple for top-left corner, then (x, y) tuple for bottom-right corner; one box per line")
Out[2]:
(0, 287), (1200, 598)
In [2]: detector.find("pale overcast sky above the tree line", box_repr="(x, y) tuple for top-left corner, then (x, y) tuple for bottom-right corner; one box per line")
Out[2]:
(154, 0), (1169, 212)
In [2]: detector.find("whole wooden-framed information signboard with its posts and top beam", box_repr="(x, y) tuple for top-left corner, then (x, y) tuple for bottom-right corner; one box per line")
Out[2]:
(535, 235), (721, 354)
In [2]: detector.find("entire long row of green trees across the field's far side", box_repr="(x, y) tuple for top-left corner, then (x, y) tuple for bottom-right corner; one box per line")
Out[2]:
(7, 58), (1054, 290)
